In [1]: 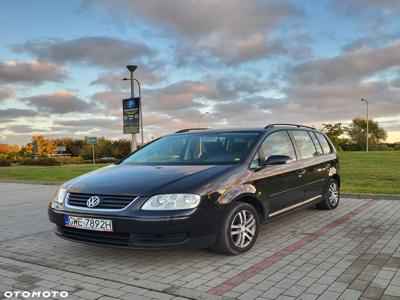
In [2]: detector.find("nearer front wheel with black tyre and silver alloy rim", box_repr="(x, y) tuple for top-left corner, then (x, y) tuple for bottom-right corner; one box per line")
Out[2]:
(211, 202), (260, 255)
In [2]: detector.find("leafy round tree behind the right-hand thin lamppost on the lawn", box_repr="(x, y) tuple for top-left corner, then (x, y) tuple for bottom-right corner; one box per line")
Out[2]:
(348, 118), (387, 150)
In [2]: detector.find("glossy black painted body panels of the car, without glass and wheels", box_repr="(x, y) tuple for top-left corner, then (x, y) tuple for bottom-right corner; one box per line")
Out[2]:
(48, 128), (340, 249)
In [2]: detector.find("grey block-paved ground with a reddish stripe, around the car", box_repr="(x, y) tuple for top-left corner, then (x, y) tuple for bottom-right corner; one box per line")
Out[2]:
(0, 183), (400, 299)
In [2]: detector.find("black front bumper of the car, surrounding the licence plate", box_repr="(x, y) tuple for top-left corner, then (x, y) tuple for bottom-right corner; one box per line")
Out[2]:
(48, 207), (222, 249)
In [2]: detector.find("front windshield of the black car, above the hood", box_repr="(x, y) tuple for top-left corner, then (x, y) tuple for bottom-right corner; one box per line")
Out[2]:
(122, 132), (259, 165)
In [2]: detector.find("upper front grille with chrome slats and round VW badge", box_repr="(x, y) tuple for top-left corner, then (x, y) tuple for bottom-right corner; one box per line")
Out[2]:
(67, 193), (136, 209)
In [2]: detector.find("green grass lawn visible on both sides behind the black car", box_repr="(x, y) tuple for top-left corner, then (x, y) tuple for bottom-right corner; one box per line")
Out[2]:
(0, 151), (400, 195)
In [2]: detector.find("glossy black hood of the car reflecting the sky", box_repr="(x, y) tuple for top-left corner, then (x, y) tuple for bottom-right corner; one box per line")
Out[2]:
(65, 165), (234, 196)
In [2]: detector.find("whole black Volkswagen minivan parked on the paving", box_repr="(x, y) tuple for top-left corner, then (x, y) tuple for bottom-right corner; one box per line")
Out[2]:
(48, 124), (340, 254)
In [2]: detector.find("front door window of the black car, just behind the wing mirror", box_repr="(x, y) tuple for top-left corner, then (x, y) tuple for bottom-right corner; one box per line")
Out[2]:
(261, 131), (296, 160)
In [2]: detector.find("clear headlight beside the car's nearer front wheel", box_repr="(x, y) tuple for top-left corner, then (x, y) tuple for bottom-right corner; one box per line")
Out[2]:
(142, 194), (200, 210)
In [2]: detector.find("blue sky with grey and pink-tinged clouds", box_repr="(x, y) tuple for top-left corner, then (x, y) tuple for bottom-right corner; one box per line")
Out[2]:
(0, 0), (400, 144)
